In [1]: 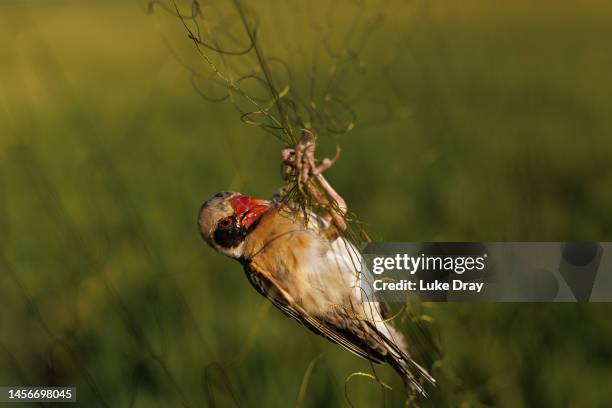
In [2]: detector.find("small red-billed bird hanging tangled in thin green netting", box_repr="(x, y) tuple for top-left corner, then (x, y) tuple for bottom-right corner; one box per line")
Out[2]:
(198, 134), (435, 395)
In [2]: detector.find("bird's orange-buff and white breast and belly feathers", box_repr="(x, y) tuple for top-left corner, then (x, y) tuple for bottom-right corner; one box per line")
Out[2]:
(245, 210), (361, 314)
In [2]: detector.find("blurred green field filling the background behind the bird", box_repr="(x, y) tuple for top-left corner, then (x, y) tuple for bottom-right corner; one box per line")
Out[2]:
(0, 0), (612, 407)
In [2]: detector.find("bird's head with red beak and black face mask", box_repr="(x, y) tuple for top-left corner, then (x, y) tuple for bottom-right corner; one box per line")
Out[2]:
(198, 191), (272, 259)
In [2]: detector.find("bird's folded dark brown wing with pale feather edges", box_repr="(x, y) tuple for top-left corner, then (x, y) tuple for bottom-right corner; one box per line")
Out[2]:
(245, 262), (386, 363)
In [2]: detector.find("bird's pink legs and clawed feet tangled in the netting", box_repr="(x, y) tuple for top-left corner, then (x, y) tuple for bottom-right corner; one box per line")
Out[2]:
(281, 129), (347, 241)
